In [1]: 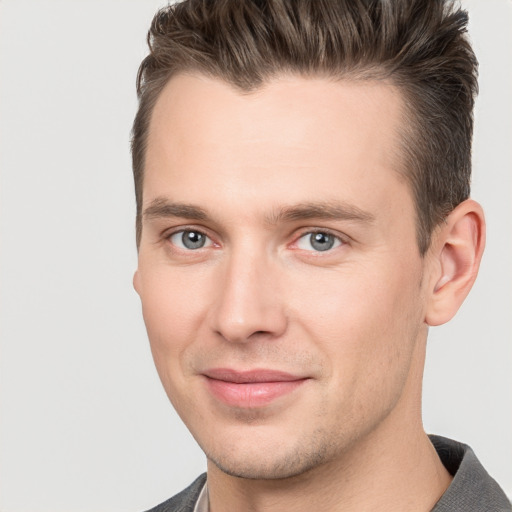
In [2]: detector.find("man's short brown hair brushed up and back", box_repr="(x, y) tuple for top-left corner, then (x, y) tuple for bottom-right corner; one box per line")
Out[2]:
(132, 0), (478, 255)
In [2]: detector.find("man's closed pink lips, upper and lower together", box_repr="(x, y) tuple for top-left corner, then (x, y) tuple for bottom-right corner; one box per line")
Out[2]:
(203, 368), (308, 408)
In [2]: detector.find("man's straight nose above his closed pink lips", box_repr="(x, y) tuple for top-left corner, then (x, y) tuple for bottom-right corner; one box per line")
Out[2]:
(211, 252), (287, 343)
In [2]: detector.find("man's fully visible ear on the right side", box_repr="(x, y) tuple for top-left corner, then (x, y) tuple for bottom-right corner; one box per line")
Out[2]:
(425, 199), (485, 326)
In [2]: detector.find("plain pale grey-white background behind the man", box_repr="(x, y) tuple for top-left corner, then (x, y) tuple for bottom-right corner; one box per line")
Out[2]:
(0, 0), (512, 512)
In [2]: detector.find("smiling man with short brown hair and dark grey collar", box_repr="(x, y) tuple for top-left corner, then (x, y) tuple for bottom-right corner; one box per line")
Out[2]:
(133, 0), (510, 512)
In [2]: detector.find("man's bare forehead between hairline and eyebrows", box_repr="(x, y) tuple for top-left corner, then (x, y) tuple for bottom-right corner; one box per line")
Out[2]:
(144, 74), (410, 224)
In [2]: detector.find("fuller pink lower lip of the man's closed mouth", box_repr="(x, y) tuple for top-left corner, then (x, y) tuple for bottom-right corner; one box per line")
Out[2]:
(206, 377), (307, 408)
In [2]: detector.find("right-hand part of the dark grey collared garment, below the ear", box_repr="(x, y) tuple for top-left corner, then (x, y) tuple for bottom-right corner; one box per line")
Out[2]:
(430, 436), (512, 512)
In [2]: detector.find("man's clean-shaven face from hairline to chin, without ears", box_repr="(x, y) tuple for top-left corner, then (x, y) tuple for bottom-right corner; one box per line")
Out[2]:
(134, 75), (427, 478)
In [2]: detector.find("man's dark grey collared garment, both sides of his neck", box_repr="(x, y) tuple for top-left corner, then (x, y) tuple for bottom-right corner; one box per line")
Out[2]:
(147, 436), (512, 512)
